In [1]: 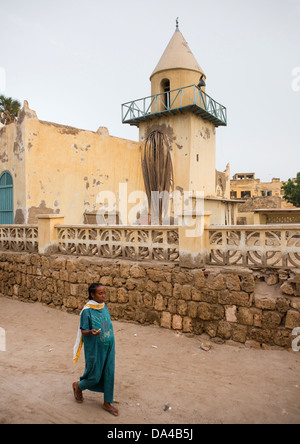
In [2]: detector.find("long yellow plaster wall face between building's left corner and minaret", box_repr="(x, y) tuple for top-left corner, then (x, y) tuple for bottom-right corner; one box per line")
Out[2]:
(27, 120), (144, 224)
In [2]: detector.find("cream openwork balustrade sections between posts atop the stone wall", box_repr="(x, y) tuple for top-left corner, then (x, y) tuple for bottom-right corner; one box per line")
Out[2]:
(0, 224), (300, 268)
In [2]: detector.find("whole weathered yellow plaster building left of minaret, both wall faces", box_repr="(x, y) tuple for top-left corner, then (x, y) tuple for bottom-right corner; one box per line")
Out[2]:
(0, 104), (144, 224)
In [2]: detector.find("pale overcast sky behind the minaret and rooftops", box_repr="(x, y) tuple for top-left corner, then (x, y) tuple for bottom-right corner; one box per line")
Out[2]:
(0, 0), (300, 181)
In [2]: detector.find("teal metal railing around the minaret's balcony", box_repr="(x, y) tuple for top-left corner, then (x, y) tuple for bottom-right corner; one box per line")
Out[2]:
(122, 85), (227, 126)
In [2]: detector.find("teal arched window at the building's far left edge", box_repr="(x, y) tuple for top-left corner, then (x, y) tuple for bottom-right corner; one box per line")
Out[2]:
(0, 171), (14, 225)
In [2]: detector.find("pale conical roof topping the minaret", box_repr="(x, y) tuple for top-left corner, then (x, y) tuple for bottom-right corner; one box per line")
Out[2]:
(150, 27), (205, 80)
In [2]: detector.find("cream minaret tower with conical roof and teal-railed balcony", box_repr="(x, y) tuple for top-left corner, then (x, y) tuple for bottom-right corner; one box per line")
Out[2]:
(122, 21), (227, 197)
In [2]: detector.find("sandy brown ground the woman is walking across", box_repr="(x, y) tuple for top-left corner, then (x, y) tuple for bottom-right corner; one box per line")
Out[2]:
(0, 297), (300, 424)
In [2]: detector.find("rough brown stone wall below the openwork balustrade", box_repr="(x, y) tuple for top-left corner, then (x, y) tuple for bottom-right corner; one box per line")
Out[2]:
(0, 252), (300, 348)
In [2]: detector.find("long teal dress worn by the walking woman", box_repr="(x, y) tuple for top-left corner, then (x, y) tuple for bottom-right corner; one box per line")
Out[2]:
(79, 305), (115, 404)
